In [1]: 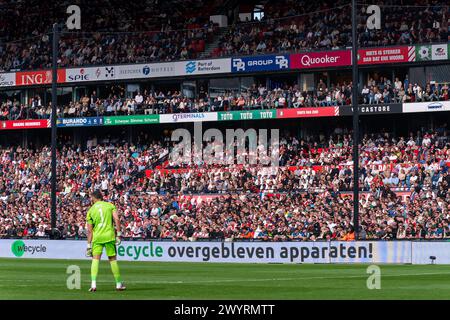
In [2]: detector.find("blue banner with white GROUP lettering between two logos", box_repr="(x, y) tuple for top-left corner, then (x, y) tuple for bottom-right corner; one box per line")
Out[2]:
(231, 54), (289, 72)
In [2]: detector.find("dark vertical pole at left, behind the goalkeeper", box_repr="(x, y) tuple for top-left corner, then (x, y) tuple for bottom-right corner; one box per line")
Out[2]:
(51, 23), (58, 239)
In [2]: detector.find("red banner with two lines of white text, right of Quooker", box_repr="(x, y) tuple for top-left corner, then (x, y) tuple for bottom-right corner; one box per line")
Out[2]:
(358, 46), (416, 65)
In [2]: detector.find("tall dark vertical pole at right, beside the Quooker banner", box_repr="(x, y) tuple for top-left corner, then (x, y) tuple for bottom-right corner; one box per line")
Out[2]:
(352, 0), (359, 240)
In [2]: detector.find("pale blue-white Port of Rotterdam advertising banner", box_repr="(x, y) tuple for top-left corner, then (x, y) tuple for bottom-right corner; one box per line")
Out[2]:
(174, 58), (231, 76)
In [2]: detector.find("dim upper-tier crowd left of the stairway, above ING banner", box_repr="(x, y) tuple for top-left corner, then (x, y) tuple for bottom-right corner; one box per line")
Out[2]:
(0, 0), (220, 71)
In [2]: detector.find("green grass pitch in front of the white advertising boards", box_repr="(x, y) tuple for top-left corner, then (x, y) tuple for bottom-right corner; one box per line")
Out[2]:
(0, 259), (450, 300)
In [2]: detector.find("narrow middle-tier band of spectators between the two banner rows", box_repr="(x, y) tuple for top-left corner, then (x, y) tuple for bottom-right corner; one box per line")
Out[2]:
(0, 77), (449, 120)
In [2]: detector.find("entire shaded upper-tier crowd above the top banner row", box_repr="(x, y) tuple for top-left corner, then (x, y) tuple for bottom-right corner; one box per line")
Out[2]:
(0, 0), (448, 71)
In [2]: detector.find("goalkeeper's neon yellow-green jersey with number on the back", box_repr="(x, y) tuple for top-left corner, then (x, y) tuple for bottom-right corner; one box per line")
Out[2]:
(86, 201), (116, 243)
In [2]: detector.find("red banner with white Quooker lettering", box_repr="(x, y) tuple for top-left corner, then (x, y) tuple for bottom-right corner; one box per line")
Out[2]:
(290, 50), (352, 69)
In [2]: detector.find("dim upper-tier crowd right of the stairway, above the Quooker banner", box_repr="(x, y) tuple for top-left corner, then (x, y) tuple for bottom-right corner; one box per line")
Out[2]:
(213, 0), (448, 56)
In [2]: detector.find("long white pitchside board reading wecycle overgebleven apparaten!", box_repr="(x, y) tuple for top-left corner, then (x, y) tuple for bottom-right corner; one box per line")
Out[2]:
(0, 239), (450, 264)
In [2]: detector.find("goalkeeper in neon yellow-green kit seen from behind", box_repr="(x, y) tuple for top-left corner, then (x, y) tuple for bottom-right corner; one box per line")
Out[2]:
(86, 191), (125, 292)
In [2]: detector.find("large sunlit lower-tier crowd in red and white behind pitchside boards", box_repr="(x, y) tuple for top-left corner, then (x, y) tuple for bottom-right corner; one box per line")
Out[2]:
(0, 127), (450, 240)
